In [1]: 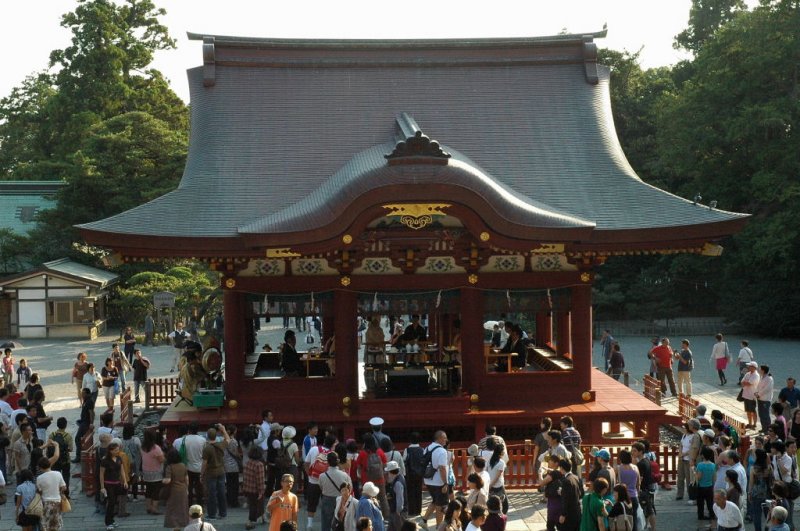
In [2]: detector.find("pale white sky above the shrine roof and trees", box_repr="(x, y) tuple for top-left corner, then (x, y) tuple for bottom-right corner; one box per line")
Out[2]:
(0, 0), (691, 101)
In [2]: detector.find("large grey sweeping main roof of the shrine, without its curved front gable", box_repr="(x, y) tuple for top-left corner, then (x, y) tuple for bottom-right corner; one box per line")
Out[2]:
(82, 36), (742, 245)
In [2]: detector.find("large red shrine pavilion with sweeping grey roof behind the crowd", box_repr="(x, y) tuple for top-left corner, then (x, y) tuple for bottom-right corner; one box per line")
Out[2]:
(80, 32), (746, 444)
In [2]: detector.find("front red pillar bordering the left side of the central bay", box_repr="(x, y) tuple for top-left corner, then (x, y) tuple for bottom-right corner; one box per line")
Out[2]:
(329, 290), (358, 438)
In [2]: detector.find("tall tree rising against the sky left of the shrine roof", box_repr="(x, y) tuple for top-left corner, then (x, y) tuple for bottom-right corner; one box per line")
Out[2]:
(46, 0), (187, 156)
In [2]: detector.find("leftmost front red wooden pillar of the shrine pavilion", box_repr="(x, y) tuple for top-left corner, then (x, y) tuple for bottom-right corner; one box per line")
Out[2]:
(222, 288), (245, 399)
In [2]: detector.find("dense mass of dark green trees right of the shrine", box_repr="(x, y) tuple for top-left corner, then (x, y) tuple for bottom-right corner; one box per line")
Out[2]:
(596, 0), (800, 335)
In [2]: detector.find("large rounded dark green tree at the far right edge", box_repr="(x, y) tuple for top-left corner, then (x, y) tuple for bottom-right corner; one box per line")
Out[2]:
(657, 1), (800, 335)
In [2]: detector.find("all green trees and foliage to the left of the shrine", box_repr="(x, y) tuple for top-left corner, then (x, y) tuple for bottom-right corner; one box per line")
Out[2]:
(0, 0), (216, 324)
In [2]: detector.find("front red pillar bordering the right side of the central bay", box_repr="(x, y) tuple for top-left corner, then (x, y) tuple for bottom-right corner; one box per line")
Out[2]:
(461, 288), (486, 393)
